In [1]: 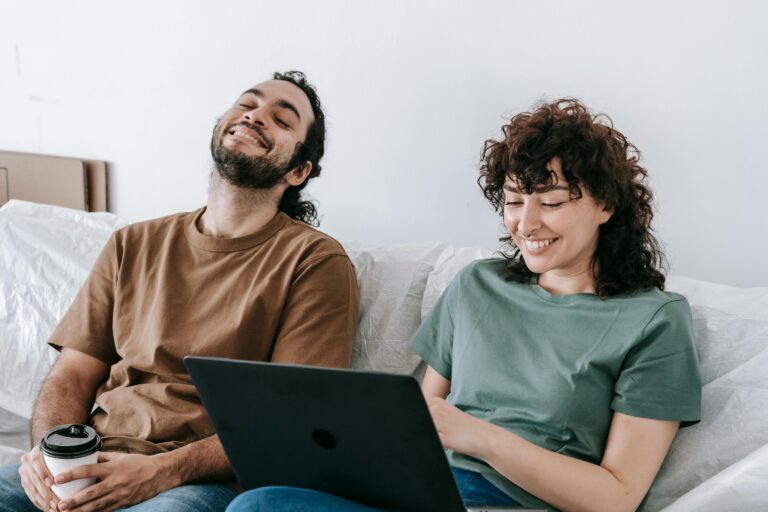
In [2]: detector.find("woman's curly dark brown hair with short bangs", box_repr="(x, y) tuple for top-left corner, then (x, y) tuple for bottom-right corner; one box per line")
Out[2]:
(477, 98), (665, 297)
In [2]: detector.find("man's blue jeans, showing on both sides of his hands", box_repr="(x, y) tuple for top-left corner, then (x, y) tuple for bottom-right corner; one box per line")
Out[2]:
(0, 464), (237, 512)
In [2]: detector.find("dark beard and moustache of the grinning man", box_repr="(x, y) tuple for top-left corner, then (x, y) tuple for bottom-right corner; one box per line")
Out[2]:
(211, 123), (300, 189)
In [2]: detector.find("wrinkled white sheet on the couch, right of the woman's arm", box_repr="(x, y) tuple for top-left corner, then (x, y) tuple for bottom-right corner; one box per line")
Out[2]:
(647, 277), (768, 512)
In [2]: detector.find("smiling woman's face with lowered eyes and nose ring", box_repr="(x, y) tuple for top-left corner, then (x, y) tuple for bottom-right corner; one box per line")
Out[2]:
(504, 157), (611, 283)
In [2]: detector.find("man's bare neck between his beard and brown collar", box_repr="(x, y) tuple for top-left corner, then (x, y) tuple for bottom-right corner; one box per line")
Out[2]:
(197, 171), (283, 238)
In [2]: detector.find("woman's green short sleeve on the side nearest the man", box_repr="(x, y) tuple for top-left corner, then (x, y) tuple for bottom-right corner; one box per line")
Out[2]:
(411, 273), (461, 380)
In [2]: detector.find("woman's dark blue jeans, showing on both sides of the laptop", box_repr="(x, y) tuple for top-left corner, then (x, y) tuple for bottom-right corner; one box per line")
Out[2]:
(227, 468), (520, 512)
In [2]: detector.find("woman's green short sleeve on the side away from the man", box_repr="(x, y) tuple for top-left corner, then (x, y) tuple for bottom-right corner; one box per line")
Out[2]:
(611, 299), (701, 427)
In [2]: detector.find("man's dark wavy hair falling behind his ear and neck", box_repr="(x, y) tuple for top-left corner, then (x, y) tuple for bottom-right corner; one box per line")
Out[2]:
(272, 71), (325, 226)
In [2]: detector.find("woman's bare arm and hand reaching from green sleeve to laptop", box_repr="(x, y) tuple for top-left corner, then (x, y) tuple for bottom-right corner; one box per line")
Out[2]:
(422, 368), (679, 511)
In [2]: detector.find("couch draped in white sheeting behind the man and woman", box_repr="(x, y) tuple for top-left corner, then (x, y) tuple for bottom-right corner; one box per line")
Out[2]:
(0, 201), (768, 512)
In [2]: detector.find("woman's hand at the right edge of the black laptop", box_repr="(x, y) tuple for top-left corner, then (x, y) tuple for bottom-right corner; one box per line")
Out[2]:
(427, 397), (495, 459)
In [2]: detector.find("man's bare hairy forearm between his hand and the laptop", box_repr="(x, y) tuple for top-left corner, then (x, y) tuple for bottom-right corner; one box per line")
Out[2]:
(156, 435), (233, 487)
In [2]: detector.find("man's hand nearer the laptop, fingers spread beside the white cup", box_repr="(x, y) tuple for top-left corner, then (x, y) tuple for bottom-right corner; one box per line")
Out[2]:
(55, 452), (178, 512)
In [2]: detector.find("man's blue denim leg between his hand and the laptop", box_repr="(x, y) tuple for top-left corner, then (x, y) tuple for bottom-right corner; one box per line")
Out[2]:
(115, 484), (237, 512)
